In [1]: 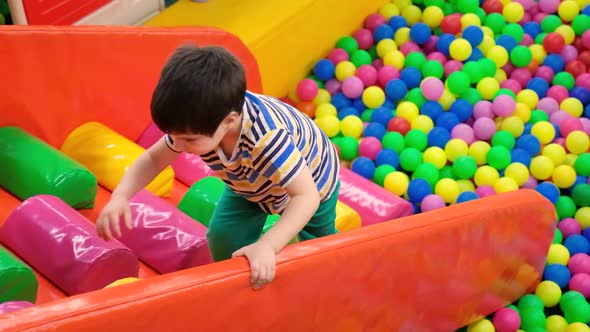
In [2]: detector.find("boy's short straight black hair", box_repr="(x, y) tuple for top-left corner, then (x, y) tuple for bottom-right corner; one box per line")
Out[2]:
(151, 45), (246, 136)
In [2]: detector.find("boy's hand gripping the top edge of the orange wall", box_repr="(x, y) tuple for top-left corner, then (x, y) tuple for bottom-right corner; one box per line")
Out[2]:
(232, 241), (276, 289)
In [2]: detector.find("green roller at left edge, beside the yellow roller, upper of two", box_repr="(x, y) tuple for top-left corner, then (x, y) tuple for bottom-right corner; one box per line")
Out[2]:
(0, 126), (97, 209)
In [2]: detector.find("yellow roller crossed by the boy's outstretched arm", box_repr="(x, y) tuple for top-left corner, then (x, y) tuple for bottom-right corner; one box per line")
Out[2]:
(61, 121), (174, 197)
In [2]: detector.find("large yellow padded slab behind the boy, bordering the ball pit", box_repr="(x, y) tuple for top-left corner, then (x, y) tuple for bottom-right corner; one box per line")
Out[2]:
(144, 0), (390, 97)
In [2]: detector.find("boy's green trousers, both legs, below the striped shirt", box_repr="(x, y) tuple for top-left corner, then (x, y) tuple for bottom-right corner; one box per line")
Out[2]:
(207, 182), (340, 261)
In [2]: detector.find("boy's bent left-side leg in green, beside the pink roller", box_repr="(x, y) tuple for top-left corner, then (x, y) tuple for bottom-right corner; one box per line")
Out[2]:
(207, 188), (267, 261)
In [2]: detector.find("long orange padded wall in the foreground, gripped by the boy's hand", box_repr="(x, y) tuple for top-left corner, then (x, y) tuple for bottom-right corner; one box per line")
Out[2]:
(0, 190), (556, 331)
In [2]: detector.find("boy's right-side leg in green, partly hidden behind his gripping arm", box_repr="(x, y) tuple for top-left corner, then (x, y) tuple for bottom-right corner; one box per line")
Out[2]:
(299, 181), (340, 241)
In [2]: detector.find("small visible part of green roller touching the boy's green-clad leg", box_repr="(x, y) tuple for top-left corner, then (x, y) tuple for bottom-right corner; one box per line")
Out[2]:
(178, 176), (226, 227)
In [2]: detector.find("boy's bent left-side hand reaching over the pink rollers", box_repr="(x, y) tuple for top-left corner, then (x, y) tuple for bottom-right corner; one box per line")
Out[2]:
(96, 197), (133, 241)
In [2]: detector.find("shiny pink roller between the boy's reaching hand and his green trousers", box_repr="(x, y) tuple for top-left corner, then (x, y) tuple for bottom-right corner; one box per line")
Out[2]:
(119, 190), (213, 273)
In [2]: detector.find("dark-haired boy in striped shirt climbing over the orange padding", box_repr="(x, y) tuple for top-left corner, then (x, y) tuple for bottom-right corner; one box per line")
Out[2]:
(97, 46), (340, 289)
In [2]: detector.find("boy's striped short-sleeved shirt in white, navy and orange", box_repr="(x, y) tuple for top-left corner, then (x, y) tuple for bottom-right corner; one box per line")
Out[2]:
(201, 91), (340, 214)
